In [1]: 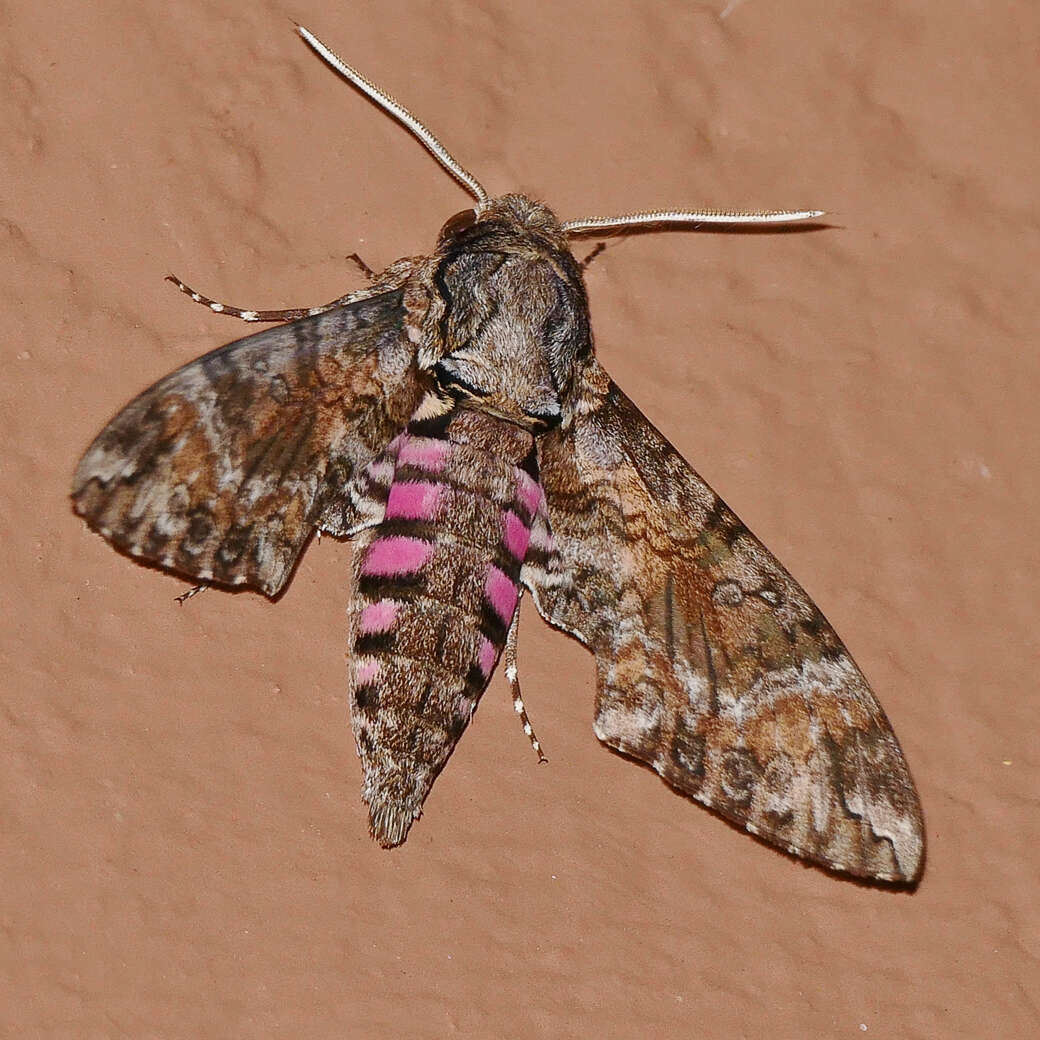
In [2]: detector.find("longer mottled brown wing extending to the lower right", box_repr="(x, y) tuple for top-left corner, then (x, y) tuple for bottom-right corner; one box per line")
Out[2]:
(523, 364), (924, 882)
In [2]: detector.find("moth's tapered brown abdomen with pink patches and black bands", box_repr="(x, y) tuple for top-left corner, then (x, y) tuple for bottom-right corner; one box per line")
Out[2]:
(350, 411), (542, 847)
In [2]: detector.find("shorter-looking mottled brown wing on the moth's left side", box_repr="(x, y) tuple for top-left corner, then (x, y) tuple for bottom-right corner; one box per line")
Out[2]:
(72, 290), (421, 596)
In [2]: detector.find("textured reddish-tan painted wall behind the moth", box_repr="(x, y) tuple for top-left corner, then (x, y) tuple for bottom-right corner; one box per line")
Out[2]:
(0, 0), (1040, 1040)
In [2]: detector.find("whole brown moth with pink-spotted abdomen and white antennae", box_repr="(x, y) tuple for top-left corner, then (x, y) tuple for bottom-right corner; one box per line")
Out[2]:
(72, 27), (924, 883)
